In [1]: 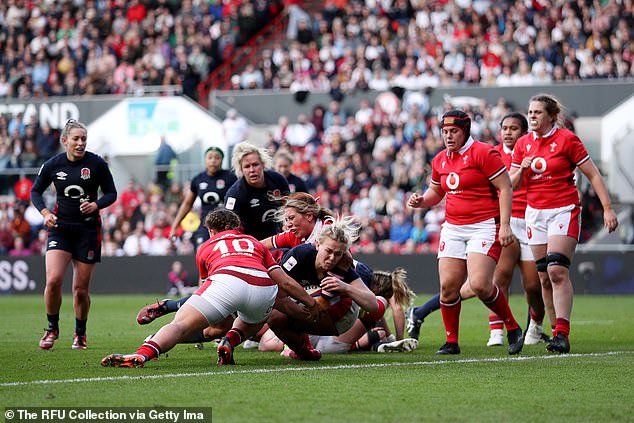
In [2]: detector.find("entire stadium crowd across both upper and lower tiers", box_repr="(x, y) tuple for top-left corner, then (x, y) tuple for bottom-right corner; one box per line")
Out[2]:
(0, 0), (634, 255)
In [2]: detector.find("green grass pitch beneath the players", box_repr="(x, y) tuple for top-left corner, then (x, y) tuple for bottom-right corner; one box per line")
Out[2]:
(0, 295), (634, 422)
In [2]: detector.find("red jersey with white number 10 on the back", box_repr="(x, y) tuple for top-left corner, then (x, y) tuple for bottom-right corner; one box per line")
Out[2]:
(196, 231), (279, 292)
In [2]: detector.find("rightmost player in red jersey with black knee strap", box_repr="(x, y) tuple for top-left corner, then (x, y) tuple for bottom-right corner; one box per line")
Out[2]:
(511, 94), (619, 353)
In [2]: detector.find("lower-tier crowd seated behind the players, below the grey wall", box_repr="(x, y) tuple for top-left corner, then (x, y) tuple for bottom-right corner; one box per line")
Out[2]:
(0, 93), (601, 256)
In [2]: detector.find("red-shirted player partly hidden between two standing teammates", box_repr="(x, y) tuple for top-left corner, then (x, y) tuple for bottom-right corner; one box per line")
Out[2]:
(487, 112), (555, 346)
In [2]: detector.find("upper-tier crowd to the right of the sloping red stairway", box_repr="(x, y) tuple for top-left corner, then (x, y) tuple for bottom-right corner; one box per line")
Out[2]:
(233, 0), (634, 89)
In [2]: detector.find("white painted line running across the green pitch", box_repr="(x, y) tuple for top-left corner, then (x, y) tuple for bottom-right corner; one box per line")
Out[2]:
(0, 351), (634, 387)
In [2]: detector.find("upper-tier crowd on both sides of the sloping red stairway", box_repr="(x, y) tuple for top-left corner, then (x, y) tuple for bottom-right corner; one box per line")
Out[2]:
(0, 0), (634, 99)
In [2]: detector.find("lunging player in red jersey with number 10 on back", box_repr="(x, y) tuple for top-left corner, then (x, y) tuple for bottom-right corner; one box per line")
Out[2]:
(101, 209), (318, 367)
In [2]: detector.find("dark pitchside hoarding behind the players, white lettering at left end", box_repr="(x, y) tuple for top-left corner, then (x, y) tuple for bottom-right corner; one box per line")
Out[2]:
(0, 251), (634, 295)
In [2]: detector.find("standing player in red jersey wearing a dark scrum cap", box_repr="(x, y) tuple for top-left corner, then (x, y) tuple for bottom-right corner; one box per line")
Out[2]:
(407, 110), (523, 354)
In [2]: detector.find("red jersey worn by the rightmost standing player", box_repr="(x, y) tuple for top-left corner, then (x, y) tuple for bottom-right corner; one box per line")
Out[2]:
(512, 127), (590, 209)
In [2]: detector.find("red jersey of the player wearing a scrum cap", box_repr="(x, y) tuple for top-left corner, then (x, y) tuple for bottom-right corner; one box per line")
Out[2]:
(431, 137), (506, 225)
